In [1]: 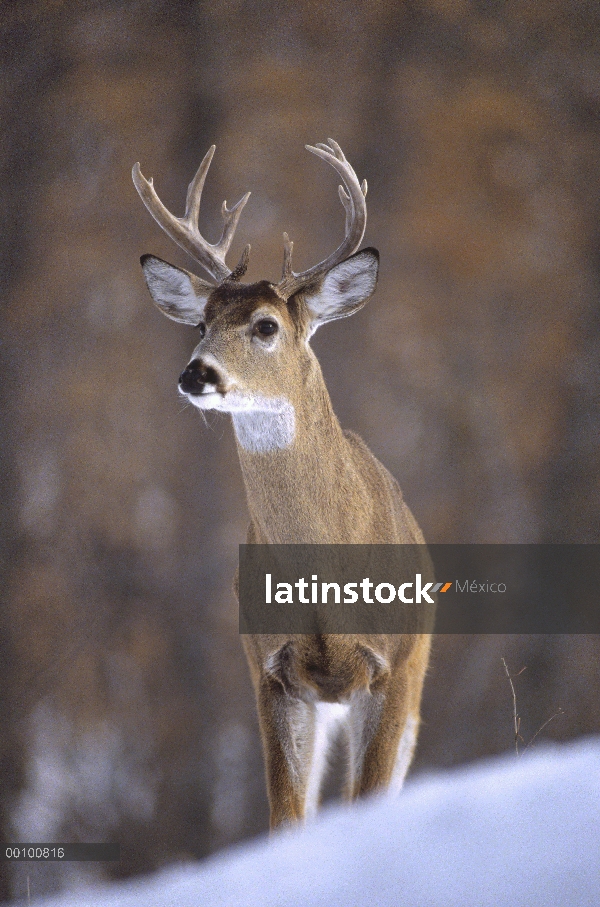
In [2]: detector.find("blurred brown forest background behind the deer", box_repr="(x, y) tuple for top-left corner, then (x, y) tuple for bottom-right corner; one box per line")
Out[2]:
(0, 0), (600, 899)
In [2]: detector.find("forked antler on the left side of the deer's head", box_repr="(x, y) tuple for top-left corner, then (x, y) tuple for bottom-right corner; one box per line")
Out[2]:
(132, 145), (250, 283)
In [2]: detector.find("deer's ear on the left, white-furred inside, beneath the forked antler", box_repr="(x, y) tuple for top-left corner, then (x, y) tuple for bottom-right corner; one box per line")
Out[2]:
(140, 255), (214, 326)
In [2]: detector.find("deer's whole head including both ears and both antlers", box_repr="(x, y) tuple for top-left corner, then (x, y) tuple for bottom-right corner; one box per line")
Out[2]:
(133, 139), (379, 444)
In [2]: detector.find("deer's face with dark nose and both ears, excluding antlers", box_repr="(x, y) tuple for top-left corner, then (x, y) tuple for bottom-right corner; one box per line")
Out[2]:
(142, 249), (378, 413)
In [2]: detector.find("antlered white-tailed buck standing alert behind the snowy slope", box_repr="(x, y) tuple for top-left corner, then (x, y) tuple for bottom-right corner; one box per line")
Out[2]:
(133, 139), (430, 828)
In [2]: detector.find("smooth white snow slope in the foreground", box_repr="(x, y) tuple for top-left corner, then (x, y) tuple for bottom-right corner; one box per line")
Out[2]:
(12, 738), (600, 907)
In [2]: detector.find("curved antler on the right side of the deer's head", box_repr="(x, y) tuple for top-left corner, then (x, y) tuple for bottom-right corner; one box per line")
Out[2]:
(277, 139), (367, 299)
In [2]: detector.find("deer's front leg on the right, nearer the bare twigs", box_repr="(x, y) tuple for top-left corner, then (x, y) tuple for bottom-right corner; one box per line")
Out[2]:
(348, 672), (419, 799)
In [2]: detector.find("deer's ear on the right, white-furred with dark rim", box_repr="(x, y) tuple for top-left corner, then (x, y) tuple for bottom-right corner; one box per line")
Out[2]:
(304, 249), (379, 334)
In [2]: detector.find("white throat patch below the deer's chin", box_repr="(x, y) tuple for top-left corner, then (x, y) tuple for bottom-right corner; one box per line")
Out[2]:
(231, 397), (296, 453)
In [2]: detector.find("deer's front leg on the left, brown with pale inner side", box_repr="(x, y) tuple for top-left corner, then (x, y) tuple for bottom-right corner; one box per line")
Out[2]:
(258, 676), (315, 829)
